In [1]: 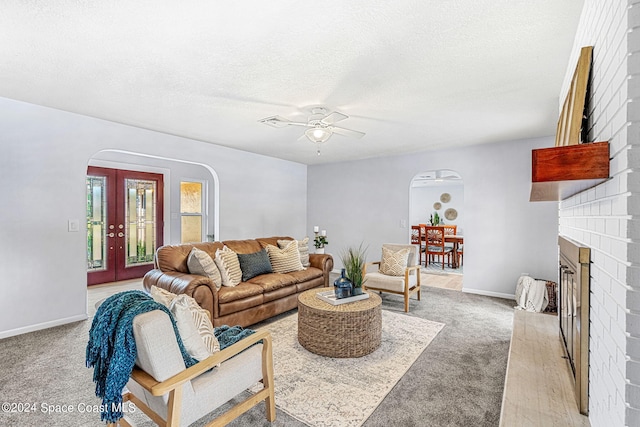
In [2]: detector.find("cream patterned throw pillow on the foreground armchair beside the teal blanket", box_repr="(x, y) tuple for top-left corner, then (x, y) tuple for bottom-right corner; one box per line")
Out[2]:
(151, 286), (220, 361)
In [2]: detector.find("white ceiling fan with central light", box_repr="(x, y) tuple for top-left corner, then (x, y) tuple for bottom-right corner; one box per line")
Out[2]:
(259, 107), (364, 155)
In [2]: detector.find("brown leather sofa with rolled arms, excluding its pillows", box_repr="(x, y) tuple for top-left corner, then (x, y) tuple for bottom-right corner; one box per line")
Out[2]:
(143, 237), (333, 327)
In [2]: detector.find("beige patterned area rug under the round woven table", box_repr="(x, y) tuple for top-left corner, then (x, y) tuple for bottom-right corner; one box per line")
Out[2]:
(251, 310), (444, 427)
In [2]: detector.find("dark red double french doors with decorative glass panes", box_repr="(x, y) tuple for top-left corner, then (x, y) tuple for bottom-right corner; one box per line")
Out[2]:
(87, 166), (164, 285)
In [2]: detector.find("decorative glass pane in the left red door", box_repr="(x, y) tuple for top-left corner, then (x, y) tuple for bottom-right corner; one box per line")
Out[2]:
(87, 176), (107, 271)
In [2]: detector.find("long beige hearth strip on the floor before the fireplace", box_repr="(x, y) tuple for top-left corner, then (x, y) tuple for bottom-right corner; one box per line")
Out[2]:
(500, 310), (590, 427)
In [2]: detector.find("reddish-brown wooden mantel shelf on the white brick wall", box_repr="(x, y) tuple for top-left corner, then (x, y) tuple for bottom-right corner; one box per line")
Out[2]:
(529, 141), (609, 202)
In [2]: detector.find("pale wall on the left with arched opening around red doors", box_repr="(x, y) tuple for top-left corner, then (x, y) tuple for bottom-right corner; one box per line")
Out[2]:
(0, 98), (307, 338)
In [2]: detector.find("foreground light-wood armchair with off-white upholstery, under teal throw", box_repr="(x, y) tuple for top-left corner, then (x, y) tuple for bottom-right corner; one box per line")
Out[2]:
(111, 310), (276, 427)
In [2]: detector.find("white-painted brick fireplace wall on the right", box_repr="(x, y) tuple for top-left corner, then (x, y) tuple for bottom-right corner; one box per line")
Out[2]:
(560, 0), (640, 427)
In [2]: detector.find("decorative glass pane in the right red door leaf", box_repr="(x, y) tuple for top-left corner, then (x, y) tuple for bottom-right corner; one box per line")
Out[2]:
(124, 179), (156, 267)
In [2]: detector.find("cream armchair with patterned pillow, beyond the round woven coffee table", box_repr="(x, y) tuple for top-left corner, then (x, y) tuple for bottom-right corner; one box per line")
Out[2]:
(363, 243), (420, 312)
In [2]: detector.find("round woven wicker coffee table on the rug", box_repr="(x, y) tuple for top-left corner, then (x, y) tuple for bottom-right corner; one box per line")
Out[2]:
(298, 288), (382, 357)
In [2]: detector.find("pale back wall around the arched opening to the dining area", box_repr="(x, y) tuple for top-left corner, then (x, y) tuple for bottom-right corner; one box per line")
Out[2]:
(307, 138), (558, 298)
